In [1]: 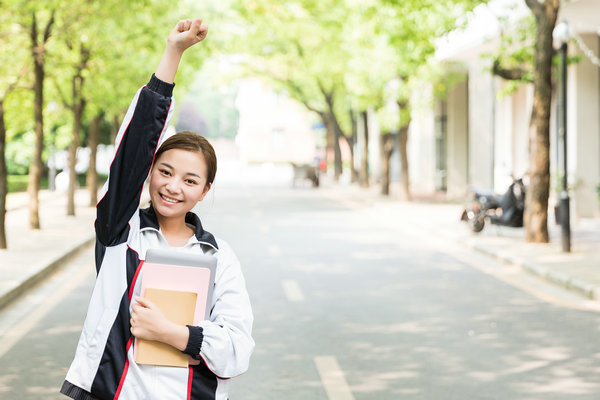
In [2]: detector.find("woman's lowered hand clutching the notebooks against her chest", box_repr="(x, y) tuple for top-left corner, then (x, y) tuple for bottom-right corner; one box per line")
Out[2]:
(130, 296), (189, 351)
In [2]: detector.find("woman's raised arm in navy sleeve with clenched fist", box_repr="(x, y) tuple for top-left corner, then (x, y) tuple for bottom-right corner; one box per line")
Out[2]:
(95, 19), (208, 246)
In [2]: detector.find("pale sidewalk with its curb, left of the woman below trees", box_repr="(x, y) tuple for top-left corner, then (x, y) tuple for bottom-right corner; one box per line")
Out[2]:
(0, 190), (96, 308)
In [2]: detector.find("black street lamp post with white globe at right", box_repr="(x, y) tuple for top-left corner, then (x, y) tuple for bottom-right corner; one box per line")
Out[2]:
(552, 21), (571, 253)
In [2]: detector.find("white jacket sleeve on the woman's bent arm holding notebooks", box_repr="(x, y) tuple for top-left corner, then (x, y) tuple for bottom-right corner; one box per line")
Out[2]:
(192, 241), (254, 379)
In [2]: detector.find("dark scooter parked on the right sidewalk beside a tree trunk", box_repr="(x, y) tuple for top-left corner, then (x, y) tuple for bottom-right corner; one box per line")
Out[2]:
(460, 177), (525, 233)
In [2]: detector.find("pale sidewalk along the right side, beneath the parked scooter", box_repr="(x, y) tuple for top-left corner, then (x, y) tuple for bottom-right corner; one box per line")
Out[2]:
(323, 185), (600, 301)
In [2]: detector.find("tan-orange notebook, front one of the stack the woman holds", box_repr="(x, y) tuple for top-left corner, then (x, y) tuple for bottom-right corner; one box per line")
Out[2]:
(135, 288), (198, 367)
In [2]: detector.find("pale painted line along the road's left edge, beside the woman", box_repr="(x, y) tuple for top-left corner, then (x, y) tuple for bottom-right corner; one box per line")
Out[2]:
(0, 262), (93, 358)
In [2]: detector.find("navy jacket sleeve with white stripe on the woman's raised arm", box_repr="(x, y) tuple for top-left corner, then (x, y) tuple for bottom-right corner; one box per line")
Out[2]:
(95, 75), (175, 246)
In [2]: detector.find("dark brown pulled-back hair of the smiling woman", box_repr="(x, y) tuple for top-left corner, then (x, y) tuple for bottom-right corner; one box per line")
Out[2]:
(154, 131), (217, 185)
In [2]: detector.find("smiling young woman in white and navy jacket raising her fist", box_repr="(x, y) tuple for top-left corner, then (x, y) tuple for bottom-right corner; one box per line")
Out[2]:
(61, 19), (254, 400)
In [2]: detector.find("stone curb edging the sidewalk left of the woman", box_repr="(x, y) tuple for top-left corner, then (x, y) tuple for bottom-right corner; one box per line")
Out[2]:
(0, 234), (96, 309)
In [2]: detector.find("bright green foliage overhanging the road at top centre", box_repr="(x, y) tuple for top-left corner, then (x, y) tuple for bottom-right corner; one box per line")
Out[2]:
(225, 0), (482, 136)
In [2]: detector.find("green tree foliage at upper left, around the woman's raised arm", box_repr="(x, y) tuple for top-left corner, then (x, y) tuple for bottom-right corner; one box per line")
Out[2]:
(0, 0), (220, 178)
